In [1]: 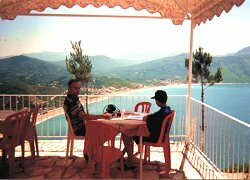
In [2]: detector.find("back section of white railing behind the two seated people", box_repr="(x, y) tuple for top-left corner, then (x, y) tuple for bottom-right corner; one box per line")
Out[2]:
(0, 95), (186, 141)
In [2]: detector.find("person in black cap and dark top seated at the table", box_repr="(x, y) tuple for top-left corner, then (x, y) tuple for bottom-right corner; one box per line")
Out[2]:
(122, 90), (172, 170)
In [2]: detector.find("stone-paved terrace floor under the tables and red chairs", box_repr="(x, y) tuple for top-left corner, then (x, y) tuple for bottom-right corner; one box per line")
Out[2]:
(1, 140), (202, 180)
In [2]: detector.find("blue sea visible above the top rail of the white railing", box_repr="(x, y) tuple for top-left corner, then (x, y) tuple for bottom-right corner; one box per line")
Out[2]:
(127, 83), (250, 124)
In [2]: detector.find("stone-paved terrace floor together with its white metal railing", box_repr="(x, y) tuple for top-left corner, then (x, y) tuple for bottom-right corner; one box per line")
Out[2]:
(0, 95), (250, 179)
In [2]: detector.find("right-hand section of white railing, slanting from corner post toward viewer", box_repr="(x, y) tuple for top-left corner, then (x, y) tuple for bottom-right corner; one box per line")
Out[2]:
(190, 98), (250, 179)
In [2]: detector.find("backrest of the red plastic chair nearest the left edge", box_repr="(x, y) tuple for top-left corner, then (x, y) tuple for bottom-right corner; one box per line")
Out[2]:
(3, 108), (29, 146)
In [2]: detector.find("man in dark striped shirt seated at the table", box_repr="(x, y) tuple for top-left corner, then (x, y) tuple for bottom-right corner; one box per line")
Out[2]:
(64, 79), (112, 159)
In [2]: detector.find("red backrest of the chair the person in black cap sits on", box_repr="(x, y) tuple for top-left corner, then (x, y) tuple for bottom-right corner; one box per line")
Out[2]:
(157, 110), (175, 144)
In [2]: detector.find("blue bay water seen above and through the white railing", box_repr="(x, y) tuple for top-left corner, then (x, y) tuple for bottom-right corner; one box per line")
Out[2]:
(37, 84), (250, 168)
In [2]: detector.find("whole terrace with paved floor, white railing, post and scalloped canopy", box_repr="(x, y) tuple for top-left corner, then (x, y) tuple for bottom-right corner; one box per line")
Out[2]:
(0, 0), (250, 179)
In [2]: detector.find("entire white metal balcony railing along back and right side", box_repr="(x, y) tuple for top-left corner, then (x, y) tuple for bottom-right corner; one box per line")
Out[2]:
(0, 95), (250, 179)
